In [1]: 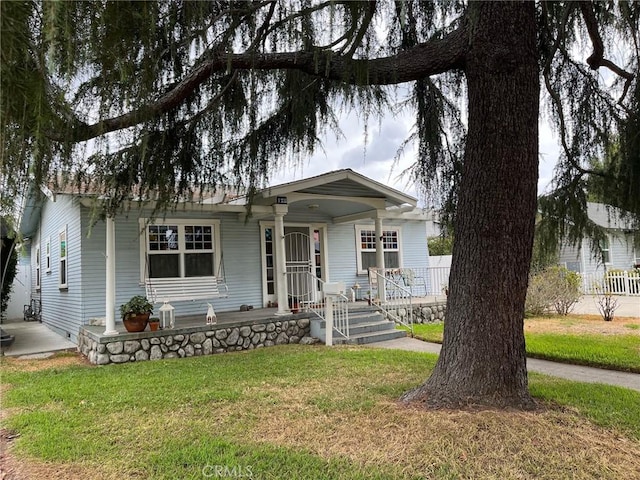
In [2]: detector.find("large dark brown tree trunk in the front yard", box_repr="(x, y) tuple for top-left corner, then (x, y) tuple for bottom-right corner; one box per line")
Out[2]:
(403, 2), (540, 408)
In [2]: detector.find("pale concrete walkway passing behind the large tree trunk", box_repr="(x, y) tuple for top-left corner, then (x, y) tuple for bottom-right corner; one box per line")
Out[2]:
(369, 337), (640, 391)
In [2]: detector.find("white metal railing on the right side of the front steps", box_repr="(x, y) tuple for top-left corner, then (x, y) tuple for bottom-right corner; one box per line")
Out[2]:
(369, 268), (413, 335)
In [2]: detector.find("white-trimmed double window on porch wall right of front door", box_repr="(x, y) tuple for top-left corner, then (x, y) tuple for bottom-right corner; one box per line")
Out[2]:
(356, 226), (401, 274)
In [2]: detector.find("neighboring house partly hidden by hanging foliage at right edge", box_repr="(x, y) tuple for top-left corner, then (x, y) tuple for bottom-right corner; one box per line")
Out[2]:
(559, 202), (640, 276)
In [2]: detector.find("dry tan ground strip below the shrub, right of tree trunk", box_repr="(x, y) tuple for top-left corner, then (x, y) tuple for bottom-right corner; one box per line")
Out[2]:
(524, 315), (640, 337)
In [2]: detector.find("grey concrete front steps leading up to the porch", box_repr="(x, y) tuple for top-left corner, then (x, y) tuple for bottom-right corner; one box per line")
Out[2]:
(311, 310), (406, 345)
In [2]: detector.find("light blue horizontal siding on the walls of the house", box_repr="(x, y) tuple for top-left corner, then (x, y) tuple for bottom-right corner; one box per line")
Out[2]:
(36, 195), (429, 340)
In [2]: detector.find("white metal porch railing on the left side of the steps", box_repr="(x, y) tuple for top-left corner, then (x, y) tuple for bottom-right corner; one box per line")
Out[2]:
(287, 269), (354, 339)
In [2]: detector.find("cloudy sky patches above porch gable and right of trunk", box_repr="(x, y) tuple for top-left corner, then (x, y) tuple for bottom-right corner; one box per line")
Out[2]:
(270, 108), (559, 206)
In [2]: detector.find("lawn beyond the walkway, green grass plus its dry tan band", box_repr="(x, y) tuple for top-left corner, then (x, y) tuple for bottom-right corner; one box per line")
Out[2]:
(404, 315), (640, 373)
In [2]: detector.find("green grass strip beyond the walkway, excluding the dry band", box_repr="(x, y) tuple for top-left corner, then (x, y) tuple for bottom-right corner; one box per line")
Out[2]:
(404, 320), (640, 373)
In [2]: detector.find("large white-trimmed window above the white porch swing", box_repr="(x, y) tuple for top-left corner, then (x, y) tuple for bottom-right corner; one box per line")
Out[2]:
(143, 220), (220, 278)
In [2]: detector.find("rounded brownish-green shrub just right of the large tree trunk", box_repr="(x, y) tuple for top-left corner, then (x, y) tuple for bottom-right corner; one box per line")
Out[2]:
(525, 266), (582, 316)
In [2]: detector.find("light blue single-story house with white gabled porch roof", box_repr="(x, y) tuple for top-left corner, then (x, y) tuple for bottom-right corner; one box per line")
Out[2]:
(20, 169), (429, 341)
